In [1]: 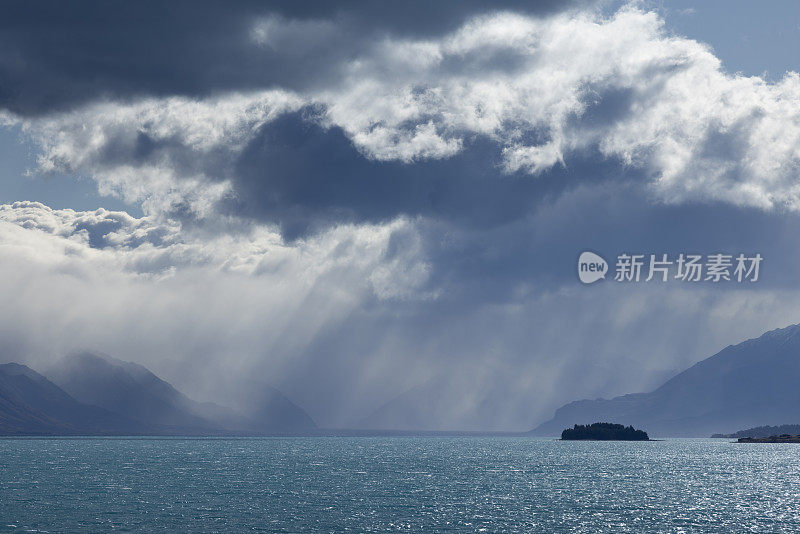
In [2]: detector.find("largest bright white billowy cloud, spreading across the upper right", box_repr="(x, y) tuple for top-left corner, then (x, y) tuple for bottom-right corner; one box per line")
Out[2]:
(322, 8), (800, 210)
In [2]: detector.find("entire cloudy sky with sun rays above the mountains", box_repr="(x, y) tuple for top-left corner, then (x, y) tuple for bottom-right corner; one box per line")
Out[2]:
(0, 0), (800, 430)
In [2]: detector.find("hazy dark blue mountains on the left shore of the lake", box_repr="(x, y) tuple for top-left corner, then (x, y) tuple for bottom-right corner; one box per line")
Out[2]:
(0, 352), (316, 435)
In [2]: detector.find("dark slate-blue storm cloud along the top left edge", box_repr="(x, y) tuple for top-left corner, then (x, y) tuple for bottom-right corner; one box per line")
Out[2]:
(0, 0), (579, 115)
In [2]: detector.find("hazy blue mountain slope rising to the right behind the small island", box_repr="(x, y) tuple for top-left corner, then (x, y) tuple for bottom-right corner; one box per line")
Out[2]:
(531, 325), (800, 437)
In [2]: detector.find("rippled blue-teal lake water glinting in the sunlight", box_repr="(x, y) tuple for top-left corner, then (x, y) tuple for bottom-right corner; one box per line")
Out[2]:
(0, 437), (800, 532)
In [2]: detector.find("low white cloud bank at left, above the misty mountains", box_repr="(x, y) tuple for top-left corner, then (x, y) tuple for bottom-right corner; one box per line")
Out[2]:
(0, 202), (429, 299)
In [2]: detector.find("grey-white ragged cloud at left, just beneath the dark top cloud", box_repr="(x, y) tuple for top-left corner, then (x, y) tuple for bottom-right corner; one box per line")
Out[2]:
(5, 91), (302, 217)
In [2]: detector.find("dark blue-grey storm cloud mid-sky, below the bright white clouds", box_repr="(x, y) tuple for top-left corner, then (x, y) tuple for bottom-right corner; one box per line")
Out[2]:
(229, 112), (580, 239)
